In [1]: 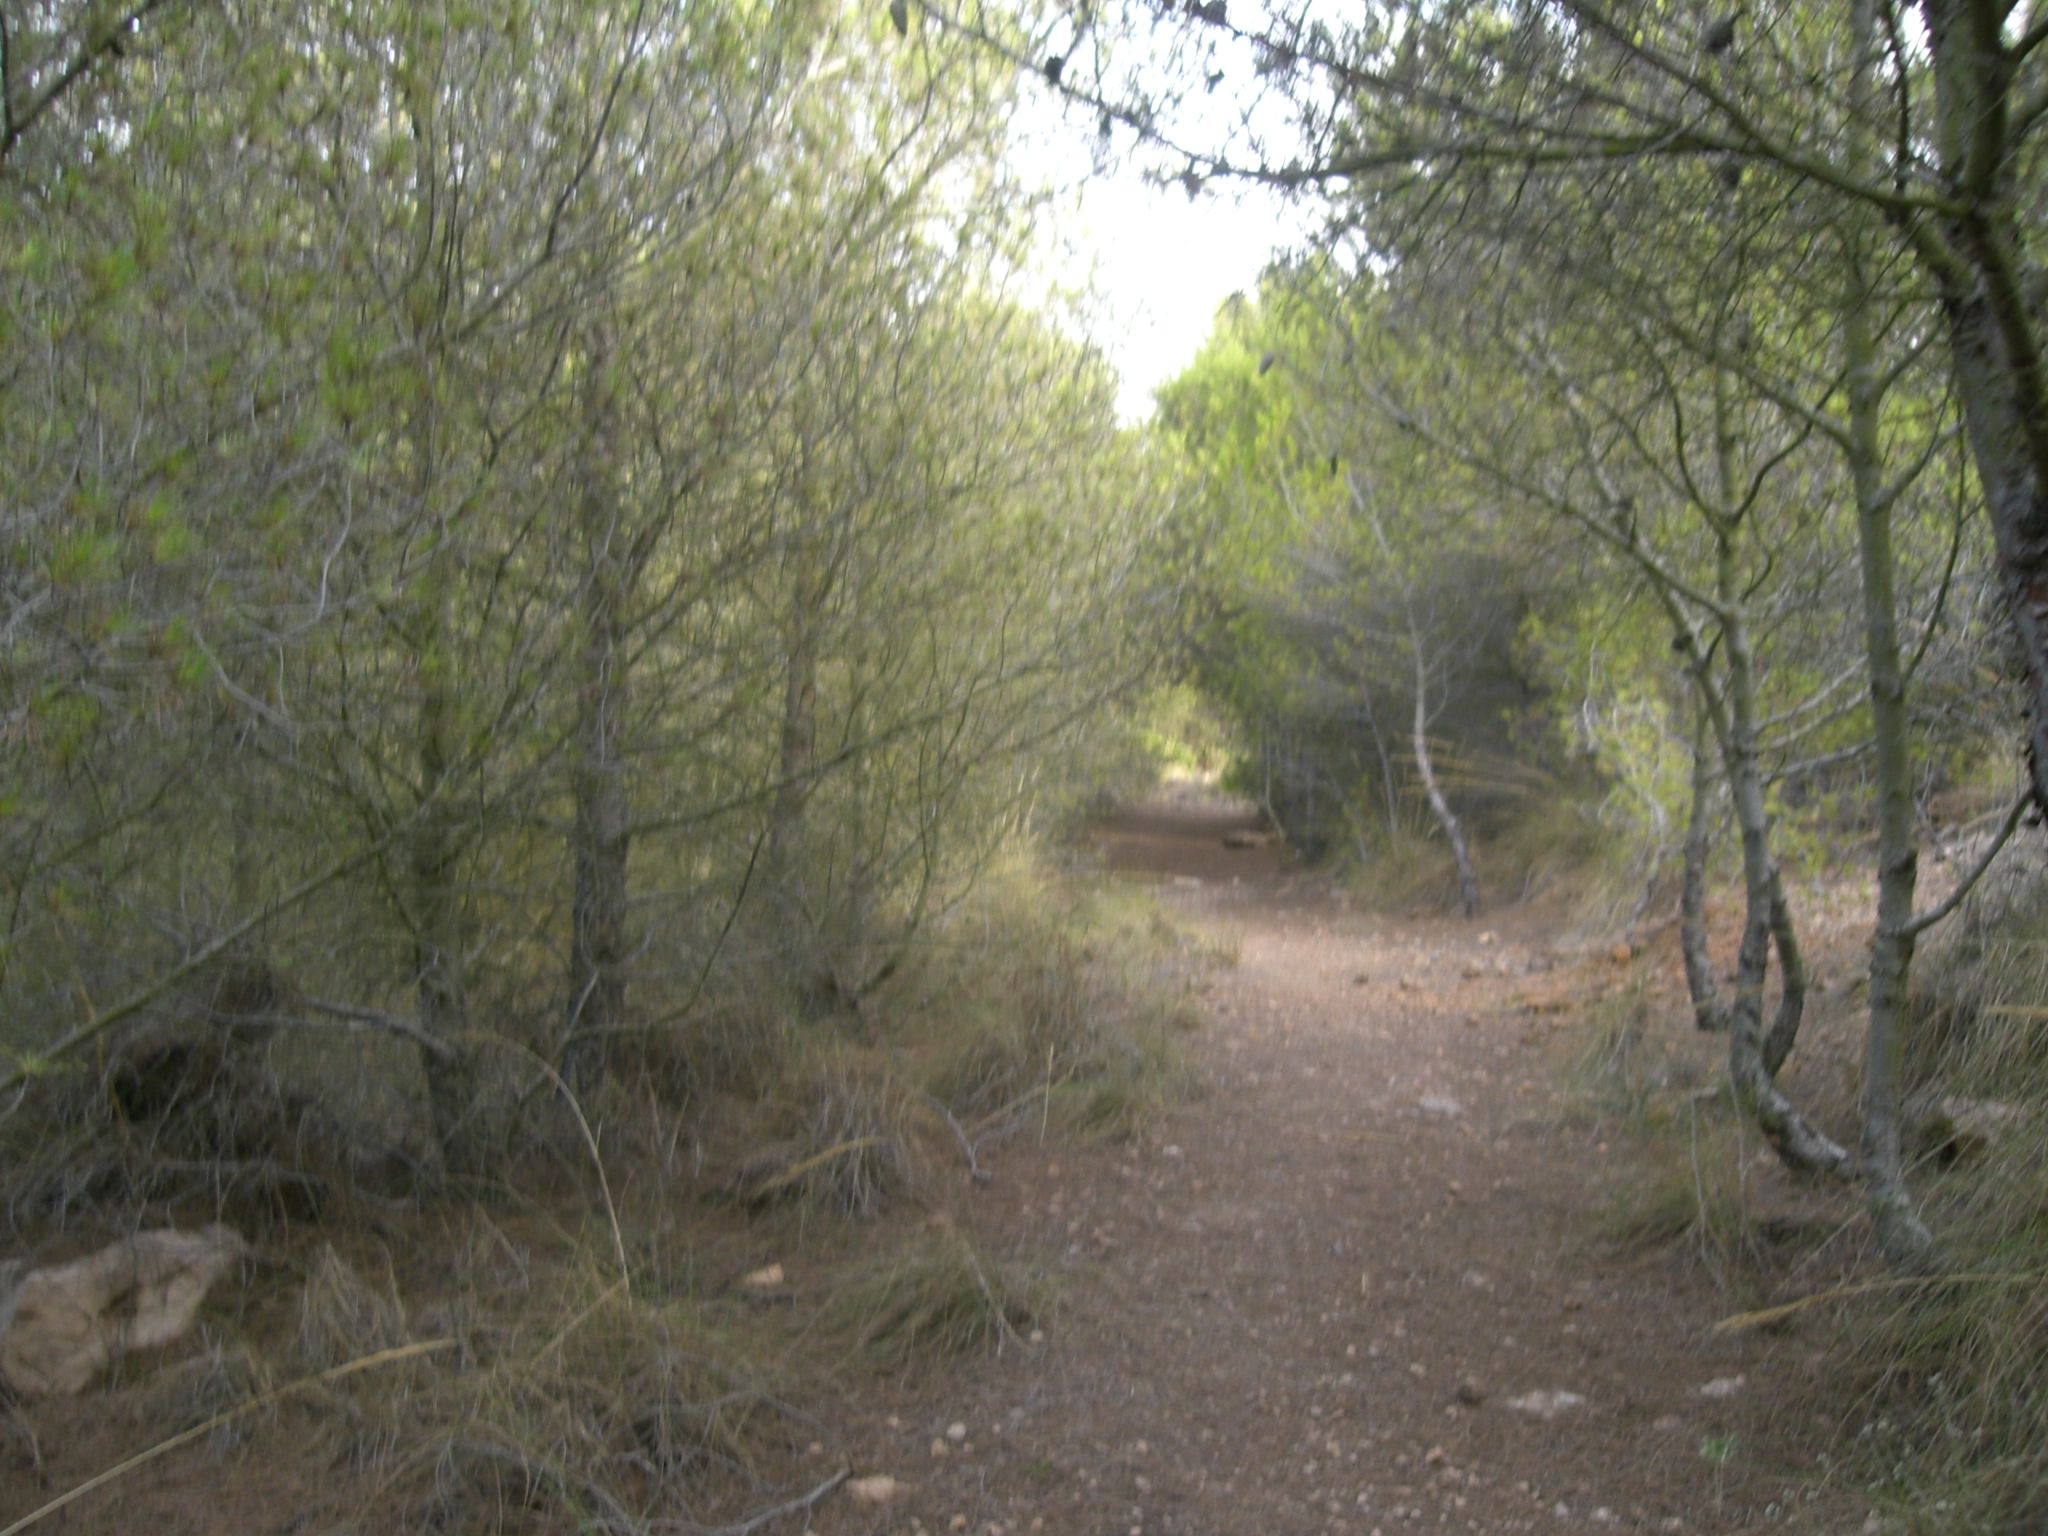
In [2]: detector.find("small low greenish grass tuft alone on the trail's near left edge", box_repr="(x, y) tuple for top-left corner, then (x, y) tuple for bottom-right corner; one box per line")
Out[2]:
(831, 1221), (1042, 1366)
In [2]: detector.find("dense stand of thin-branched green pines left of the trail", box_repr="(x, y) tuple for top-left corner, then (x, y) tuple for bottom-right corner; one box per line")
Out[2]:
(0, 0), (1151, 1167)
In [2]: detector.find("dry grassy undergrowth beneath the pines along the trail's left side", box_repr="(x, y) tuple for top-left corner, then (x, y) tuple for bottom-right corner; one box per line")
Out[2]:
(0, 858), (1217, 1534)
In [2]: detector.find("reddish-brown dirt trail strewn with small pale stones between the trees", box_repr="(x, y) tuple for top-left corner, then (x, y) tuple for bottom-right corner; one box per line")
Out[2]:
(819, 801), (1862, 1536)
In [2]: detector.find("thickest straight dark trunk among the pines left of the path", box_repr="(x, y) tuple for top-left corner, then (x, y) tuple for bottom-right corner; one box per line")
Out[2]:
(561, 322), (633, 1092)
